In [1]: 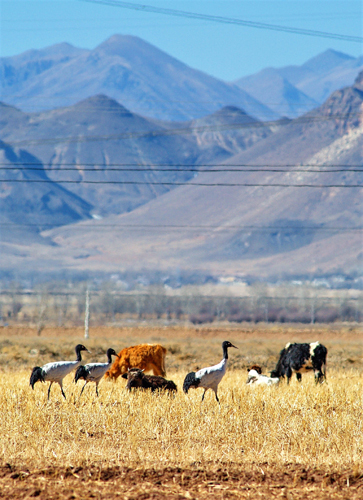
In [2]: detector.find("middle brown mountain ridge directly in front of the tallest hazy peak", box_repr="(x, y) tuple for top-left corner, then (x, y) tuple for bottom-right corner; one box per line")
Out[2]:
(0, 95), (279, 217)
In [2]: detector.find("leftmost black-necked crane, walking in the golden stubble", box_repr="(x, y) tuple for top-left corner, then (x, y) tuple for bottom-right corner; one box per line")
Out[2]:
(30, 344), (89, 399)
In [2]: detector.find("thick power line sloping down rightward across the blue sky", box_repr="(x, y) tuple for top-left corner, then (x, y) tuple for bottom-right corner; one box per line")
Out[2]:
(81, 0), (363, 43)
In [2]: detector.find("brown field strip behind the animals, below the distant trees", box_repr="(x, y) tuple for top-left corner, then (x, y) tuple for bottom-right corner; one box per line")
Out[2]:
(0, 323), (363, 371)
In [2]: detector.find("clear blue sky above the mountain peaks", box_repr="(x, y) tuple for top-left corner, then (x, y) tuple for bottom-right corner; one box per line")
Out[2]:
(0, 0), (362, 81)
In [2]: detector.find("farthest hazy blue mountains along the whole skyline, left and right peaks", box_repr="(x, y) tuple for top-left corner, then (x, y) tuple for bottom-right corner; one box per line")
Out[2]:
(0, 35), (363, 121)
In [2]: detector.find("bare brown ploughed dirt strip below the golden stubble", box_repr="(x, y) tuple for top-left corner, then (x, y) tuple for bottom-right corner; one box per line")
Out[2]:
(0, 464), (363, 500)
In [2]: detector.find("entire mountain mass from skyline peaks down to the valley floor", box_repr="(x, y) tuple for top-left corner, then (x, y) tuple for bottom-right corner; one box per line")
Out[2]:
(0, 36), (363, 277)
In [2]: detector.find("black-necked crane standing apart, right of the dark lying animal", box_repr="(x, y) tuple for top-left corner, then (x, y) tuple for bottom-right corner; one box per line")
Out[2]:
(183, 340), (238, 403)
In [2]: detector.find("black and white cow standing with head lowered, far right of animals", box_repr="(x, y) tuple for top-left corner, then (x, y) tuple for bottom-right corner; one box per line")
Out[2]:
(271, 342), (328, 383)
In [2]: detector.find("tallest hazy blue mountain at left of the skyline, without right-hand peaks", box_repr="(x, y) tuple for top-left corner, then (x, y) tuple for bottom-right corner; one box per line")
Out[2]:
(0, 35), (278, 121)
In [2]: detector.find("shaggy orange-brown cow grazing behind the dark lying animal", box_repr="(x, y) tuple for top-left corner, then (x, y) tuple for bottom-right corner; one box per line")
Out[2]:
(105, 344), (166, 380)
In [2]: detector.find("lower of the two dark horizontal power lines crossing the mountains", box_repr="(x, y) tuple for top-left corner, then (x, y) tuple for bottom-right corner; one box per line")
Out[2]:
(0, 179), (363, 189)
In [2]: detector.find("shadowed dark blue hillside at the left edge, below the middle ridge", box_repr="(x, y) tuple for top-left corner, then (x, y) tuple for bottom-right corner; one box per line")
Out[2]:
(0, 141), (92, 255)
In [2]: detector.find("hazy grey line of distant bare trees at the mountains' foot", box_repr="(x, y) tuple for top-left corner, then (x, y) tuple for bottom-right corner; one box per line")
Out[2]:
(0, 283), (363, 328)
